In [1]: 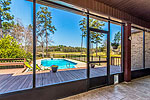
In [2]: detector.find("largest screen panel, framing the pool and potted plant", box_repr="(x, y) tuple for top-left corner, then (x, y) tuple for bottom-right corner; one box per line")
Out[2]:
(36, 4), (87, 87)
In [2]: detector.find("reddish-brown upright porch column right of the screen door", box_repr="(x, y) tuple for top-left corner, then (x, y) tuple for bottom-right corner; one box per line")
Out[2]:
(124, 23), (131, 82)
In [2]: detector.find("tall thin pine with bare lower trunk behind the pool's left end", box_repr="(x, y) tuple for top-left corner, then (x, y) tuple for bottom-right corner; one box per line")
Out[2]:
(37, 7), (56, 56)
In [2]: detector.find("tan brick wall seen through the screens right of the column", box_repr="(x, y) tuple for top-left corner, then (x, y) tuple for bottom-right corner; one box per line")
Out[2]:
(131, 31), (150, 70)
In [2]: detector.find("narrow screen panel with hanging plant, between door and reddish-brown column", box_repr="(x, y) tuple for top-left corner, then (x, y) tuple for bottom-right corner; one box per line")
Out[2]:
(110, 23), (123, 74)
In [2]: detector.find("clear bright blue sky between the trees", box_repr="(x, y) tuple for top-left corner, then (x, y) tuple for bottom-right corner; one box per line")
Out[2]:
(11, 0), (121, 47)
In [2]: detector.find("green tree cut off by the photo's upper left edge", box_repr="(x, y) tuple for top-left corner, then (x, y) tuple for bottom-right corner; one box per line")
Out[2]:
(0, 0), (14, 37)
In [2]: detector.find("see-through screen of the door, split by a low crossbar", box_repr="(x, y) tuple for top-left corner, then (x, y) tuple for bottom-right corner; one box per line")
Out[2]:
(90, 31), (107, 78)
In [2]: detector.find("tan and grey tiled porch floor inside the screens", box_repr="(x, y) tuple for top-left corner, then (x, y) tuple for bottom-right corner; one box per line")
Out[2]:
(61, 76), (150, 100)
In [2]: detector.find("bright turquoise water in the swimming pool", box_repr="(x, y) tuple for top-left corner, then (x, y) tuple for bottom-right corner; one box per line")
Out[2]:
(41, 59), (77, 69)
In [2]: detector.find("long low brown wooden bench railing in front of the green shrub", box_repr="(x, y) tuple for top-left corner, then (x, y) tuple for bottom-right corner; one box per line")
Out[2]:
(0, 58), (26, 68)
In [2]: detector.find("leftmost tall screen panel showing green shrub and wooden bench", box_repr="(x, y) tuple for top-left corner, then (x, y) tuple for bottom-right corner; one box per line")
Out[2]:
(0, 0), (33, 94)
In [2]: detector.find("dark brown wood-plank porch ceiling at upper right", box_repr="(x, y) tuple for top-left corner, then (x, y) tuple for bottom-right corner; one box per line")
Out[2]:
(96, 0), (150, 22)
